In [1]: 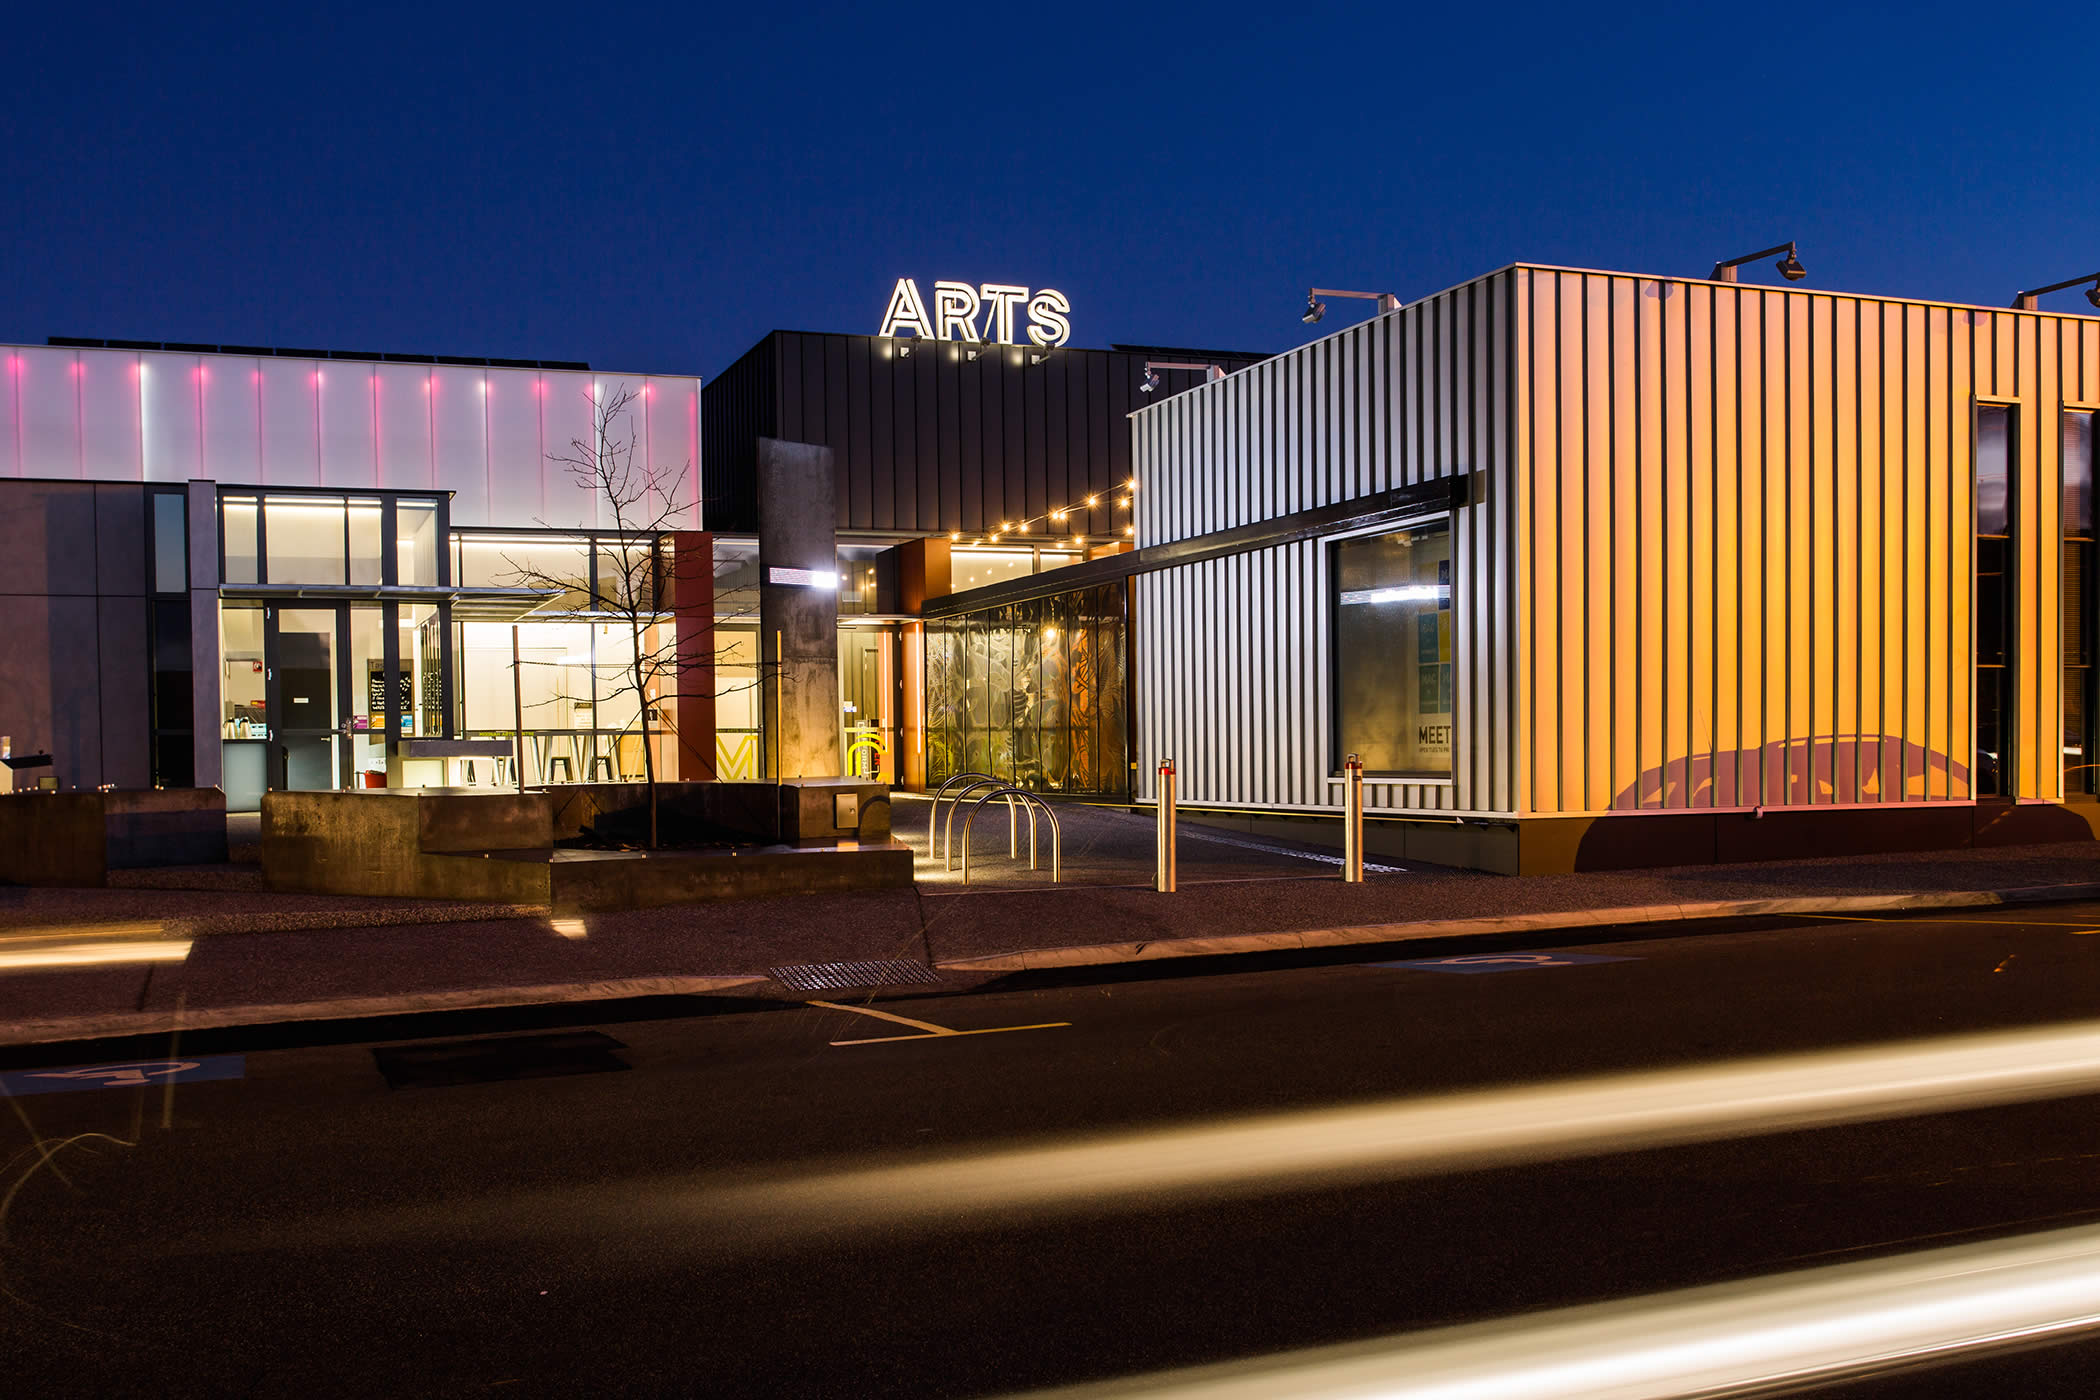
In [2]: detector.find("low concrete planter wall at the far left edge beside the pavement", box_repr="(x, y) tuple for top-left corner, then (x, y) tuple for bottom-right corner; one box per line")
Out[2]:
(0, 787), (227, 886)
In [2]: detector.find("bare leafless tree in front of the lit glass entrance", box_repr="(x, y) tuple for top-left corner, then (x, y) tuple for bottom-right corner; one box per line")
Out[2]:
(504, 384), (756, 850)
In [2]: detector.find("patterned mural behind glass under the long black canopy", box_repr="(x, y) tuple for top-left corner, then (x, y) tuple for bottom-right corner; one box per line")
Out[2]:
(926, 584), (1130, 798)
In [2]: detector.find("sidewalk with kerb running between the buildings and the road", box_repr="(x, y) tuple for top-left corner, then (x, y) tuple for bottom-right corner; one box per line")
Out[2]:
(0, 822), (2100, 1045)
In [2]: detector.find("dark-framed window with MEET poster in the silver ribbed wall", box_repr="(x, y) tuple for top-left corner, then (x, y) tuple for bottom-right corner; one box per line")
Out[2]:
(1334, 521), (1451, 777)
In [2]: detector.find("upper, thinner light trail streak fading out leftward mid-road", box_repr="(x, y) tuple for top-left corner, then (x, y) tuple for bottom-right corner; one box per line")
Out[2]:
(695, 1022), (2100, 1222)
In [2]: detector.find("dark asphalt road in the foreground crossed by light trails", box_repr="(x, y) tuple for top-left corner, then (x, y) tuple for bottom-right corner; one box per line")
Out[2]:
(0, 905), (2100, 1400)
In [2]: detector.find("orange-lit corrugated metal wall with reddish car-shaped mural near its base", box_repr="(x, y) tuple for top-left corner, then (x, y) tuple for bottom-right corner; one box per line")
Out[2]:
(1520, 269), (2100, 814)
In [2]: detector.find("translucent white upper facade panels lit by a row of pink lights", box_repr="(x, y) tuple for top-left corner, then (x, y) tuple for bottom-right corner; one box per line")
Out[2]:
(0, 346), (699, 529)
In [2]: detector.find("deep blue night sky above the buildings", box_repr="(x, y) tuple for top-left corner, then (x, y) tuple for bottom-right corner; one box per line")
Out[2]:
(0, 4), (2100, 376)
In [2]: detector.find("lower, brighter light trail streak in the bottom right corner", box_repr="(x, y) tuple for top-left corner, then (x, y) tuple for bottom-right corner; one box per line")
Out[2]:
(999, 1226), (2100, 1400)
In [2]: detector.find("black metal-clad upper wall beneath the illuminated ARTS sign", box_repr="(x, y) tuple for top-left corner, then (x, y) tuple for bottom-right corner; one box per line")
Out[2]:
(704, 332), (1256, 535)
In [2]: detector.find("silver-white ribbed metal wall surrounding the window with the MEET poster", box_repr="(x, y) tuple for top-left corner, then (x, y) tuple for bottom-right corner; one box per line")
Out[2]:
(1132, 273), (1518, 814)
